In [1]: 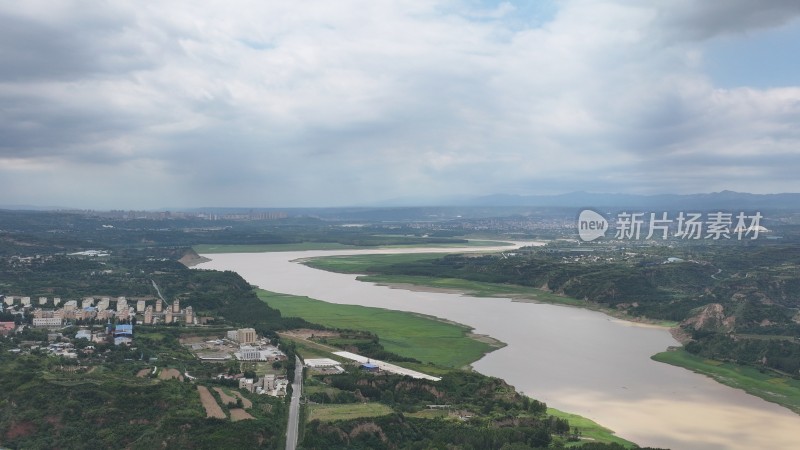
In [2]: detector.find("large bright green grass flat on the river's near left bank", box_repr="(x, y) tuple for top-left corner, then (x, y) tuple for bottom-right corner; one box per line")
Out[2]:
(257, 290), (497, 367)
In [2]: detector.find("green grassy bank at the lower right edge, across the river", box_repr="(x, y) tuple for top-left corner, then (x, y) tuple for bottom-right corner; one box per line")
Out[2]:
(652, 350), (800, 414)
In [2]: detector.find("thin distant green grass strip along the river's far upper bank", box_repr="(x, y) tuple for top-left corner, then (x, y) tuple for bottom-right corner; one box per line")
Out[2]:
(192, 240), (513, 254)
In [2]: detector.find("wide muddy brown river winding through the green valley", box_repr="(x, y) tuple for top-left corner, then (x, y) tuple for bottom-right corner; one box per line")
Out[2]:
(197, 248), (800, 450)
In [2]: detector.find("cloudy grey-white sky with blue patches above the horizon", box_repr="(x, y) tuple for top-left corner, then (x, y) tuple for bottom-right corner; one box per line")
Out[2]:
(0, 0), (800, 209)
